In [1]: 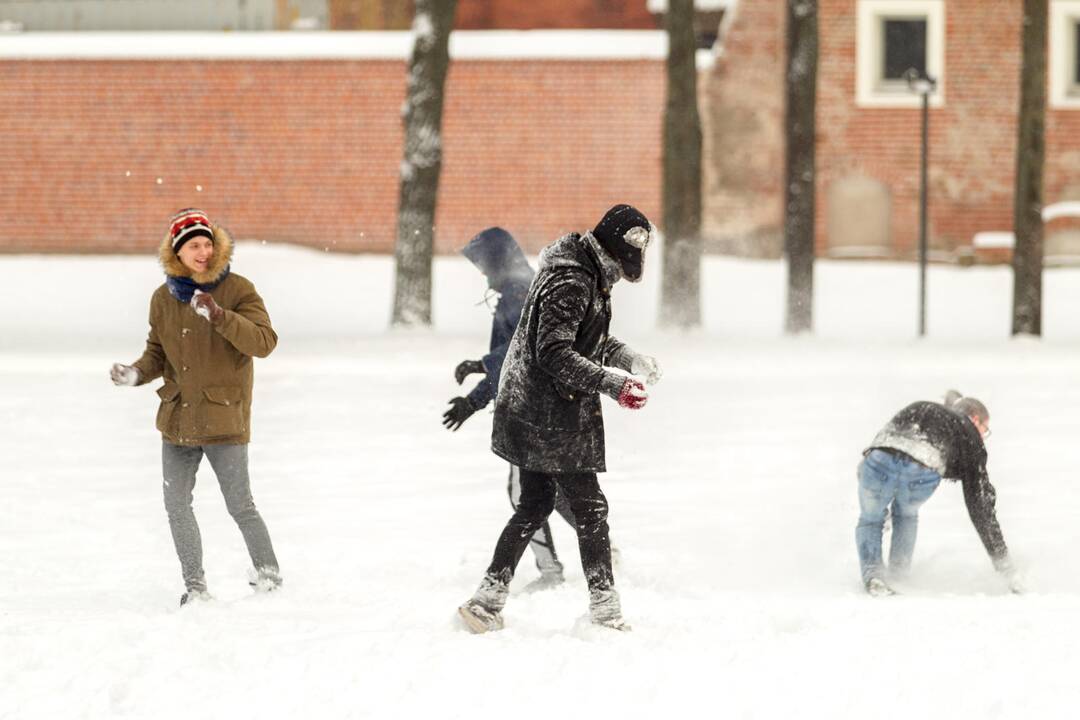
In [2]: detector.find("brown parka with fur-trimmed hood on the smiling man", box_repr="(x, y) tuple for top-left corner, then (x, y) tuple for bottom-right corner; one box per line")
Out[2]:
(134, 228), (278, 445)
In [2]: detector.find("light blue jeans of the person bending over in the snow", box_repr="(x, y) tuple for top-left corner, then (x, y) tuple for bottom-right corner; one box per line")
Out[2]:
(855, 450), (942, 583)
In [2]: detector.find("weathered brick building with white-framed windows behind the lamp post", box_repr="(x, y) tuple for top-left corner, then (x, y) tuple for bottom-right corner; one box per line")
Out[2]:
(703, 0), (1080, 257)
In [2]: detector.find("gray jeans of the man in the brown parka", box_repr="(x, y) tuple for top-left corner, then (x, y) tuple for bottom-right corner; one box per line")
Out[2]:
(161, 441), (279, 590)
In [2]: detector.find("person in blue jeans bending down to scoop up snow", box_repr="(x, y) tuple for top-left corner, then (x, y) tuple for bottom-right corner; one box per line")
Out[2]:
(855, 391), (1023, 596)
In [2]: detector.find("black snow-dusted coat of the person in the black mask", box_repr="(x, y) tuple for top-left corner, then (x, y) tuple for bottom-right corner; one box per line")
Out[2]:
(491, 233), (624, 473)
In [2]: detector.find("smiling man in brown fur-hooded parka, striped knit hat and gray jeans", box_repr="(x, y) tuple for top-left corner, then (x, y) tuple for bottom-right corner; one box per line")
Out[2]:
(110, 208), (281, 606)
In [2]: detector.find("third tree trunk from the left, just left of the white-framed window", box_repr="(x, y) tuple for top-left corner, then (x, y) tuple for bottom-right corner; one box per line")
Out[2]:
(784, 0), (818, 334)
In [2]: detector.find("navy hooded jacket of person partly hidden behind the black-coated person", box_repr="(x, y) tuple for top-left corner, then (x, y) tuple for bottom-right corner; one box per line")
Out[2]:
(461, 228), (536, 409)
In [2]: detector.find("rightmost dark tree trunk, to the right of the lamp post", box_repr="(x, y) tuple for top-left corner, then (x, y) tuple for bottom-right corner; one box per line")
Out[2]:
(1012, 0), (1048, 336)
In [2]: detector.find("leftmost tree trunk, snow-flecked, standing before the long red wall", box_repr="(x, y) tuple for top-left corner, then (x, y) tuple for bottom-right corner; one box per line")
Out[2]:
(391, 0), (456, 326)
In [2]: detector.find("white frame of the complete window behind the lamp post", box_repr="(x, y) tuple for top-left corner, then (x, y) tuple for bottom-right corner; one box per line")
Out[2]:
(855, 0), (945, 108)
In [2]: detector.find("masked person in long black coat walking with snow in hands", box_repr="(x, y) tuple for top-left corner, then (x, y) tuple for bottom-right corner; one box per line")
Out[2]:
(458, 205), (661, 633)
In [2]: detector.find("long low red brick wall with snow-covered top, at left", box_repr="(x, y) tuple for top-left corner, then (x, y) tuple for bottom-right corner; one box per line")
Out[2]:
(0, 52), (664, 253)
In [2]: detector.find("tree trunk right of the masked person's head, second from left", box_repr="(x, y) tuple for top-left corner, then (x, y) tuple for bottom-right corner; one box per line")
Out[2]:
(660, 0), (701, 328)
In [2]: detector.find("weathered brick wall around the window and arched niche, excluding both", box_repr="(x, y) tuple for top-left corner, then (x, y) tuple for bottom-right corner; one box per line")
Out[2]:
(706, 0), (1080, 255)
